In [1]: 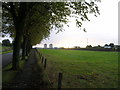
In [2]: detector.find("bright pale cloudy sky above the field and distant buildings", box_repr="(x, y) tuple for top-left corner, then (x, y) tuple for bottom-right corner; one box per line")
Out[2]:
(1, 0), (120, 48)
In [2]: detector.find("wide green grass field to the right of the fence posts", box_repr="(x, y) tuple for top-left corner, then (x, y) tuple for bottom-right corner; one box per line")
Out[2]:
(40, 49), (118, 88)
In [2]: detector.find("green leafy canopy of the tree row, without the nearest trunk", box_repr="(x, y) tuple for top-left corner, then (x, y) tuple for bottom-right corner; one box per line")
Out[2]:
(3, 0), (100, 45)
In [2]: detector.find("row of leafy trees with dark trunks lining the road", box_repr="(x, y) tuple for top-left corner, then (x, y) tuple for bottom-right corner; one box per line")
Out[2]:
(2, 0), (99, 70)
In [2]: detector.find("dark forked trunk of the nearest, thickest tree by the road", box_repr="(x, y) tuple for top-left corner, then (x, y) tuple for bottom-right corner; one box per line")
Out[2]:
(10, 2), (27, 70)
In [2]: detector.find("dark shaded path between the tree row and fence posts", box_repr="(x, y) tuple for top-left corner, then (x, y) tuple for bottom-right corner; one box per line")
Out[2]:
(2, 50), (49, 89)
